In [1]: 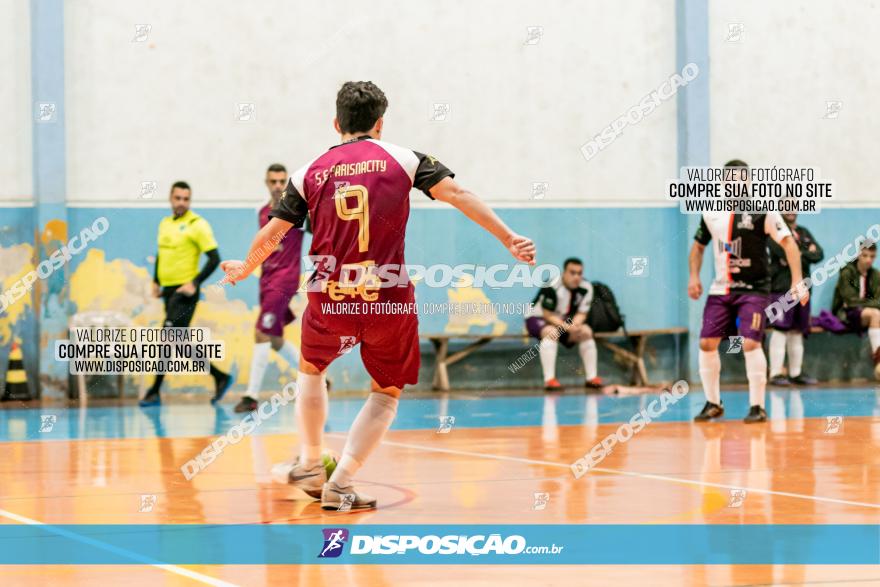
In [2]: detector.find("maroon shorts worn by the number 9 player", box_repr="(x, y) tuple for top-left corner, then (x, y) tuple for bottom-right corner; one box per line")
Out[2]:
(300, 285), (421, 388)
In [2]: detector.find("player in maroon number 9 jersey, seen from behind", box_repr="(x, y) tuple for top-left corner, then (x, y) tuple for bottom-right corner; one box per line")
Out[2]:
(221, 82), (536, 509)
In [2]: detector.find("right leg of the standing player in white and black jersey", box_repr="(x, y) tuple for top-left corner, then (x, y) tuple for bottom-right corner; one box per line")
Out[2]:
(736, 294), (767, 424)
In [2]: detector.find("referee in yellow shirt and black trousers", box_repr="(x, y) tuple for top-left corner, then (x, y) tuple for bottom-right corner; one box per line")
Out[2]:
(140, 181), (232, 408)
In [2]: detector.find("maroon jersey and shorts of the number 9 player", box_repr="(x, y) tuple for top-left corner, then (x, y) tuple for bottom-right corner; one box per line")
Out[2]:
(271, 136), (453, 387)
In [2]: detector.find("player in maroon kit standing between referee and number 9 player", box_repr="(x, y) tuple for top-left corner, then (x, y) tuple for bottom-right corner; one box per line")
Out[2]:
(235, 163), (303, 413)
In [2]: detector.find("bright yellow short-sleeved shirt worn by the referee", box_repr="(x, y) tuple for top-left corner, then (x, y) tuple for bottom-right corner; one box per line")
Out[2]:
(157, 210), (217, 287)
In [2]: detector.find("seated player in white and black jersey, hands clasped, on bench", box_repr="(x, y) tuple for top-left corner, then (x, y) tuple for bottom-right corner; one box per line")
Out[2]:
(526, 257), (602, 391)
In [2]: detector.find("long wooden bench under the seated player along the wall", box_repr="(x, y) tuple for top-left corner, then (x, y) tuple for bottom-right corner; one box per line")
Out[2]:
(420, 327), (688, 391)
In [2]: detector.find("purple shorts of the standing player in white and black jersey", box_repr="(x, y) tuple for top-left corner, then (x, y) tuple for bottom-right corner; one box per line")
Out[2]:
(700, 293), (767, 342)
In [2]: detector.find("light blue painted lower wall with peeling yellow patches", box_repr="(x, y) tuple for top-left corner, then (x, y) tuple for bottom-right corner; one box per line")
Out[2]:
(0, 202), (880, 388)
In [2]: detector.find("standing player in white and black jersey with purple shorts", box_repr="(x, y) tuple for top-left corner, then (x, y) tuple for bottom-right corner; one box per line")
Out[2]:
(688, 160), (809, 423)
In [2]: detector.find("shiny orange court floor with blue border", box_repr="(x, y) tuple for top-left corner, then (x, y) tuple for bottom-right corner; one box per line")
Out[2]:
(0, 388), (880, 587)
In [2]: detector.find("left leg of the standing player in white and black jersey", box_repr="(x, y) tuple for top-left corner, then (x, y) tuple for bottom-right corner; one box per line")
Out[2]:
(694, 295), (736, 422)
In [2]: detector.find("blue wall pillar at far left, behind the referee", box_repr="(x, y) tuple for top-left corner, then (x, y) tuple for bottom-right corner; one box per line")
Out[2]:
(31, 0), (70, 397)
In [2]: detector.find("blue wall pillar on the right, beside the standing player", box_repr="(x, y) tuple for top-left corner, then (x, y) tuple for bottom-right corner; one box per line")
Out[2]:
(675, 0), (711, 381)
